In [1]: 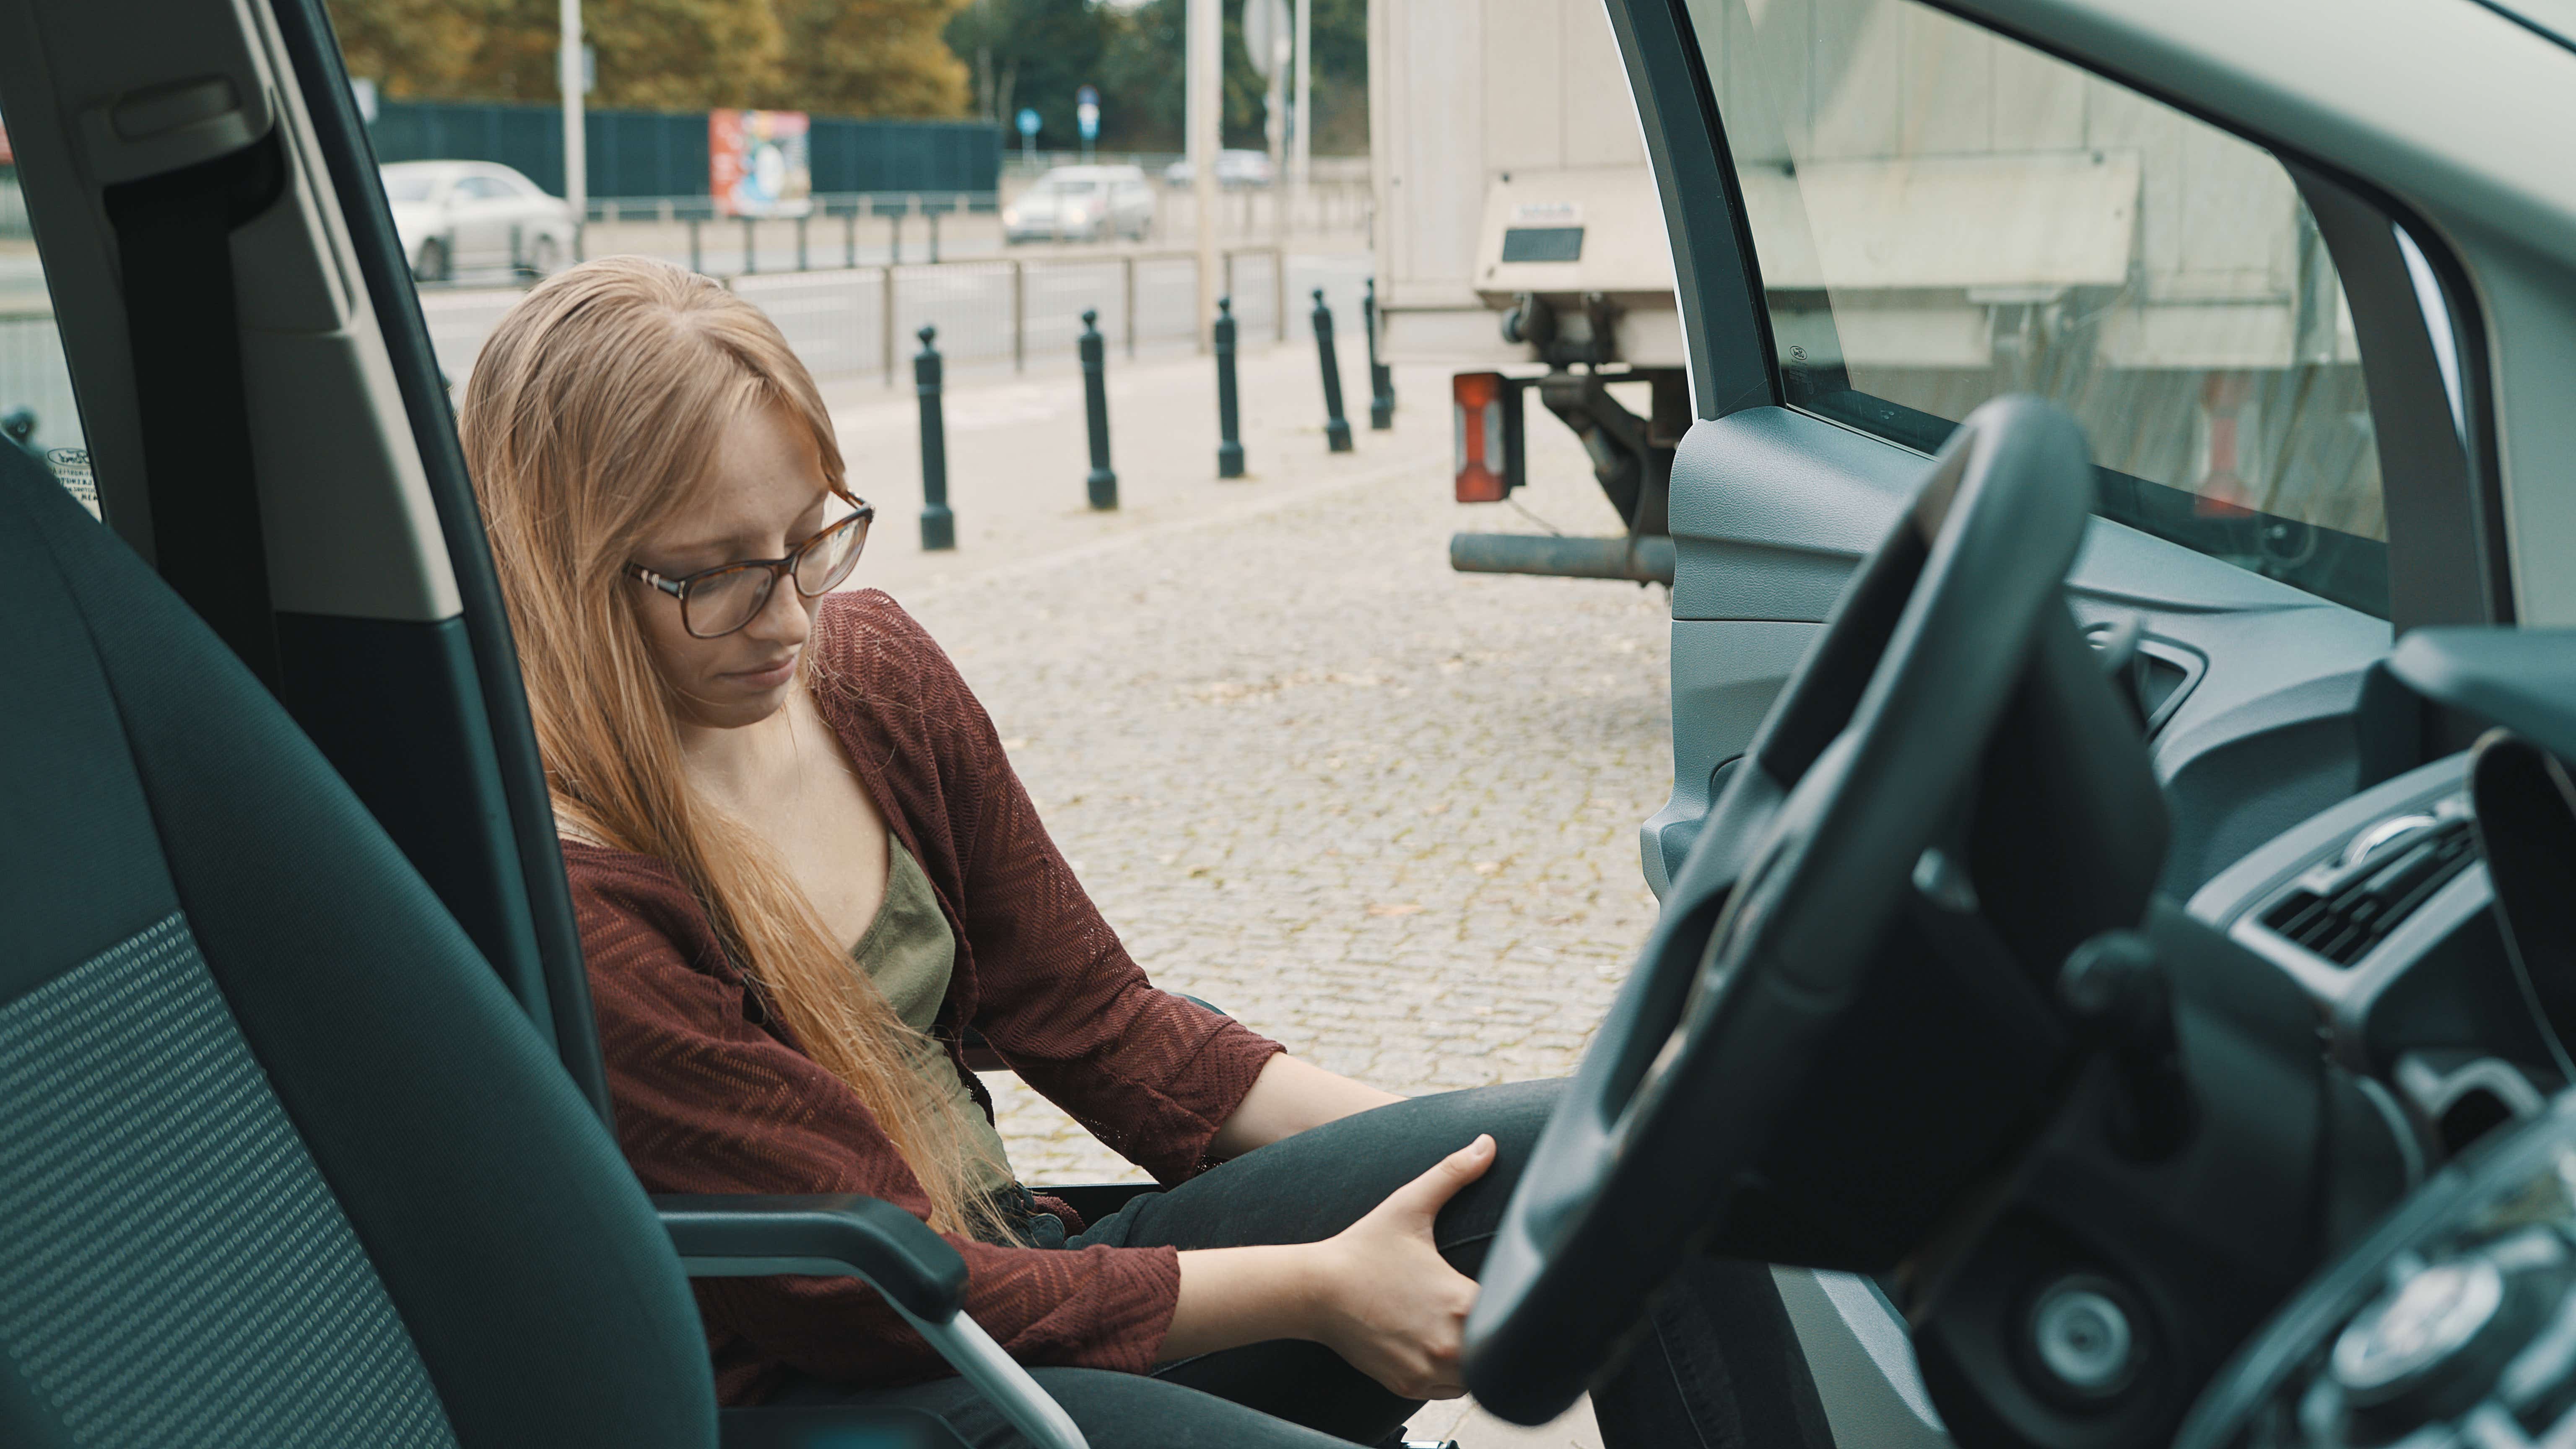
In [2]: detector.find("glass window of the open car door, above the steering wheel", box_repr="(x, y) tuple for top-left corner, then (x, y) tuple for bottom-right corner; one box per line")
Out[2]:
(1690, 0), (2388, 616)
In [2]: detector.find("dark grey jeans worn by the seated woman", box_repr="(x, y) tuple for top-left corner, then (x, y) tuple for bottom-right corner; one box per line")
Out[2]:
(770, 1083), (1831, 1449)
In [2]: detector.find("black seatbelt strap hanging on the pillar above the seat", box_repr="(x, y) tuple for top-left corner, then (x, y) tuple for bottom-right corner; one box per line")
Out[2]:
(106, 132), (286, 693)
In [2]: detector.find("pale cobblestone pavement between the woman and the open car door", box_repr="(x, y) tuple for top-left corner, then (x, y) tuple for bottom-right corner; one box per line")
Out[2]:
(855, 353), (1672, 1181)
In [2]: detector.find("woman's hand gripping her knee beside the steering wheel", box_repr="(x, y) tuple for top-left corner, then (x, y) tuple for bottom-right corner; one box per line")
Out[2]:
(1314, 1137), (1494, 1397)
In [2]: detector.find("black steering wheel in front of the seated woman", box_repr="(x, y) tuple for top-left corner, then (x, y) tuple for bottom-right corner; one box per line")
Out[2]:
(1466, 397), (2122, 1423)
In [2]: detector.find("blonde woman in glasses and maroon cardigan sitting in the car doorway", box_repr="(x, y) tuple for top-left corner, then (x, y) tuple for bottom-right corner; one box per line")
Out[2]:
(461, 258), (1821, 1446)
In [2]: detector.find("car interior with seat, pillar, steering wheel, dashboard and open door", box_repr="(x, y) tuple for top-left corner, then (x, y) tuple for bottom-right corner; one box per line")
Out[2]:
(15, 0), (2576, 1449)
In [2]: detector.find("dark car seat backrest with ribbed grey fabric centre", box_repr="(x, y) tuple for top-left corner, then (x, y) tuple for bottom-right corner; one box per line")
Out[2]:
(0, 446), (716, 1449)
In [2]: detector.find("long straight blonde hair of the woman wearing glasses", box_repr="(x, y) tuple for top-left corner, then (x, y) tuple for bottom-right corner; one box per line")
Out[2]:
(459, 258), (1010, 1238)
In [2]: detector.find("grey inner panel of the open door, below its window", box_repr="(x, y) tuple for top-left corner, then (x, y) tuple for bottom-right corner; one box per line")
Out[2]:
(1641, 408), (2391, 895)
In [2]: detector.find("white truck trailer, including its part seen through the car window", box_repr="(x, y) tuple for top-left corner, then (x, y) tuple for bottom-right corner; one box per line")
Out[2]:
(1368, 0), (2378, 583)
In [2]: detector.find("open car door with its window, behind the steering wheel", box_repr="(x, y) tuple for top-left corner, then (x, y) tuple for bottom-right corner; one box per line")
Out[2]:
(1610, 0), (2514, 892)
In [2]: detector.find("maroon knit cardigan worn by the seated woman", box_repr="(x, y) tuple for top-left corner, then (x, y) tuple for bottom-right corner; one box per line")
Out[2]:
(564, 590), (1280, 1405)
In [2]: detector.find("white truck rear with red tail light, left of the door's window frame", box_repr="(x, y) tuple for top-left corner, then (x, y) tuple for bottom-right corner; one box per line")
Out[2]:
(1368, 0), (1690, 583)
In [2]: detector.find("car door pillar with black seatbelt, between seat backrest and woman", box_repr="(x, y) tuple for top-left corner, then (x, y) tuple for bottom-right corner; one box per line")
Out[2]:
(0, 0), (608, 1114)
